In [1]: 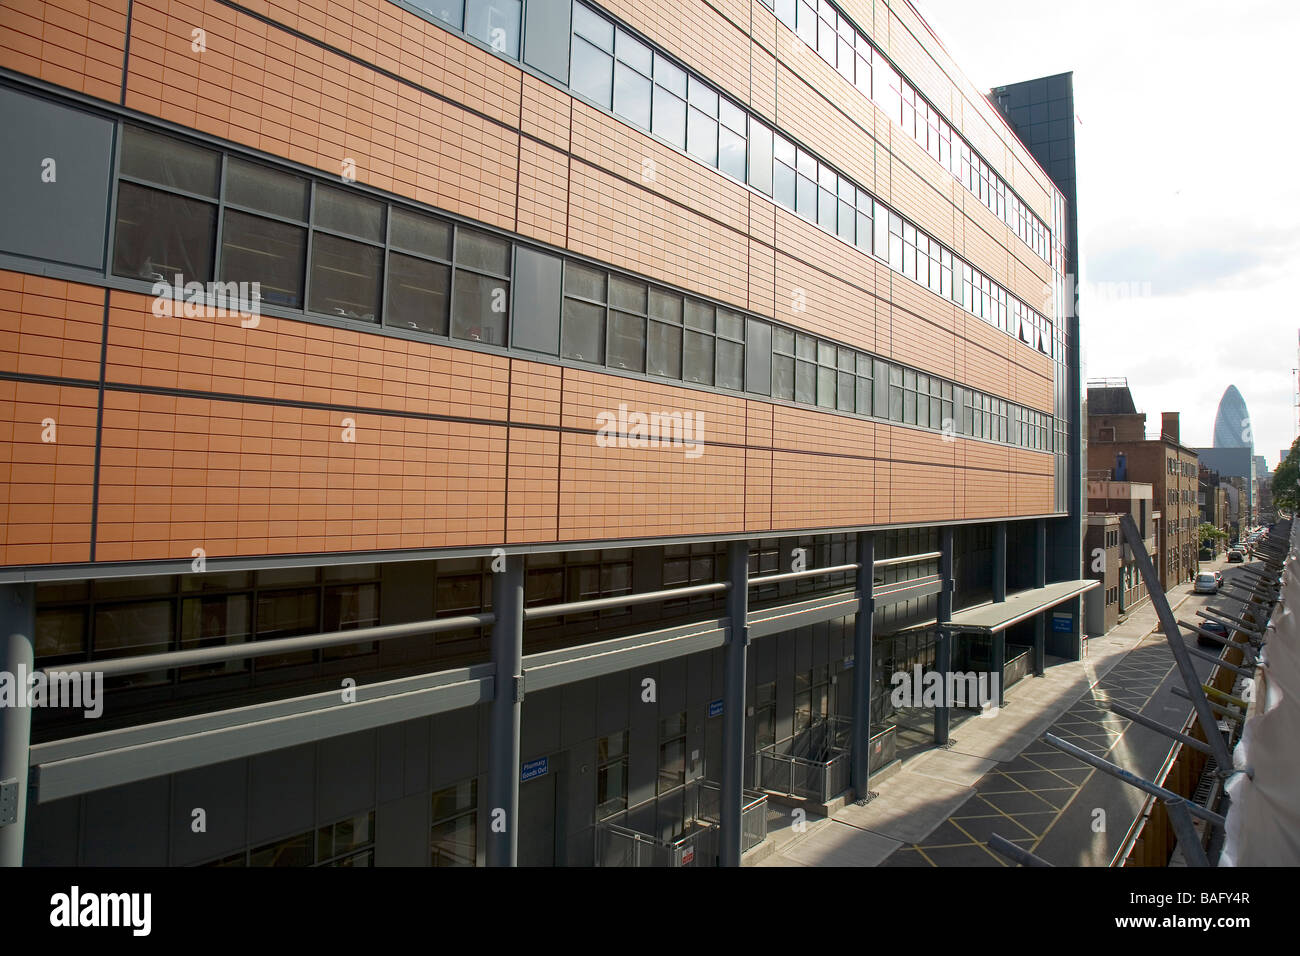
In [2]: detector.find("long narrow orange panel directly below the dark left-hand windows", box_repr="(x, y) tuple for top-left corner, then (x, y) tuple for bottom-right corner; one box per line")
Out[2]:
(105, 291), (510, 420)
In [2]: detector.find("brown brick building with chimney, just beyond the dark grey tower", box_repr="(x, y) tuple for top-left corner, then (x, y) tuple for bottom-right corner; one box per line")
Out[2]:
(1088, 380), (1200, 591)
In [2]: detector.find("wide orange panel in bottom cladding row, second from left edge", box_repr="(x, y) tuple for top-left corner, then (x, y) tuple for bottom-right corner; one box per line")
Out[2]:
(96, 392), (506, 561)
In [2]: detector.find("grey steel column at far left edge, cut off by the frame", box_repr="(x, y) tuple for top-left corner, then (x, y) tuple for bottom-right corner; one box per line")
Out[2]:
(0, 584), (36, 866)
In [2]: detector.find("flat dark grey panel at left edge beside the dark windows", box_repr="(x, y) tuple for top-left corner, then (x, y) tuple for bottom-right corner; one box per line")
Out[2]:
(0, 87), (113, 269)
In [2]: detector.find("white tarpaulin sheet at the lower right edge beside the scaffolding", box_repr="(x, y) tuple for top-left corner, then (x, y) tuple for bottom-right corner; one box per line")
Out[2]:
(1219, 522), (1300, 866)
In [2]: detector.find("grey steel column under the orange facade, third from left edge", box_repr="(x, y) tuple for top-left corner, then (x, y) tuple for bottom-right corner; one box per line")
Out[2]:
(718, 541), (749, 866)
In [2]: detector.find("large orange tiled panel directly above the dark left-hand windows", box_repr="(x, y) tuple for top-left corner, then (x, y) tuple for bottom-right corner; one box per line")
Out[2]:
(126, 0), (520, 229)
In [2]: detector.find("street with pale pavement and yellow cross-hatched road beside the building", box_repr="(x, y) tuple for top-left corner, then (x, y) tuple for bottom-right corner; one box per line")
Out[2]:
(755, 559), (1238, 866)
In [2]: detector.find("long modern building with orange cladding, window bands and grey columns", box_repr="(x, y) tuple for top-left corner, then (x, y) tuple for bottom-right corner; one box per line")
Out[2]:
(0, 0), (1092, 866)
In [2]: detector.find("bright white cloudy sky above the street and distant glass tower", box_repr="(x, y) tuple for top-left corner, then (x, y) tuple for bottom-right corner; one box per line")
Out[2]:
(913, 0), (1300, 470)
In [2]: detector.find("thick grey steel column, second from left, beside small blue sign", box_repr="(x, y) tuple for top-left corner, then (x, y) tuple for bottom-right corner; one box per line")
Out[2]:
(486, 555), (524, 866)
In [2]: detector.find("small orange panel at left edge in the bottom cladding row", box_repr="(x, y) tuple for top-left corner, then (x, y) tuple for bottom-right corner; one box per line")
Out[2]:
(0, 380), (99, 564)
